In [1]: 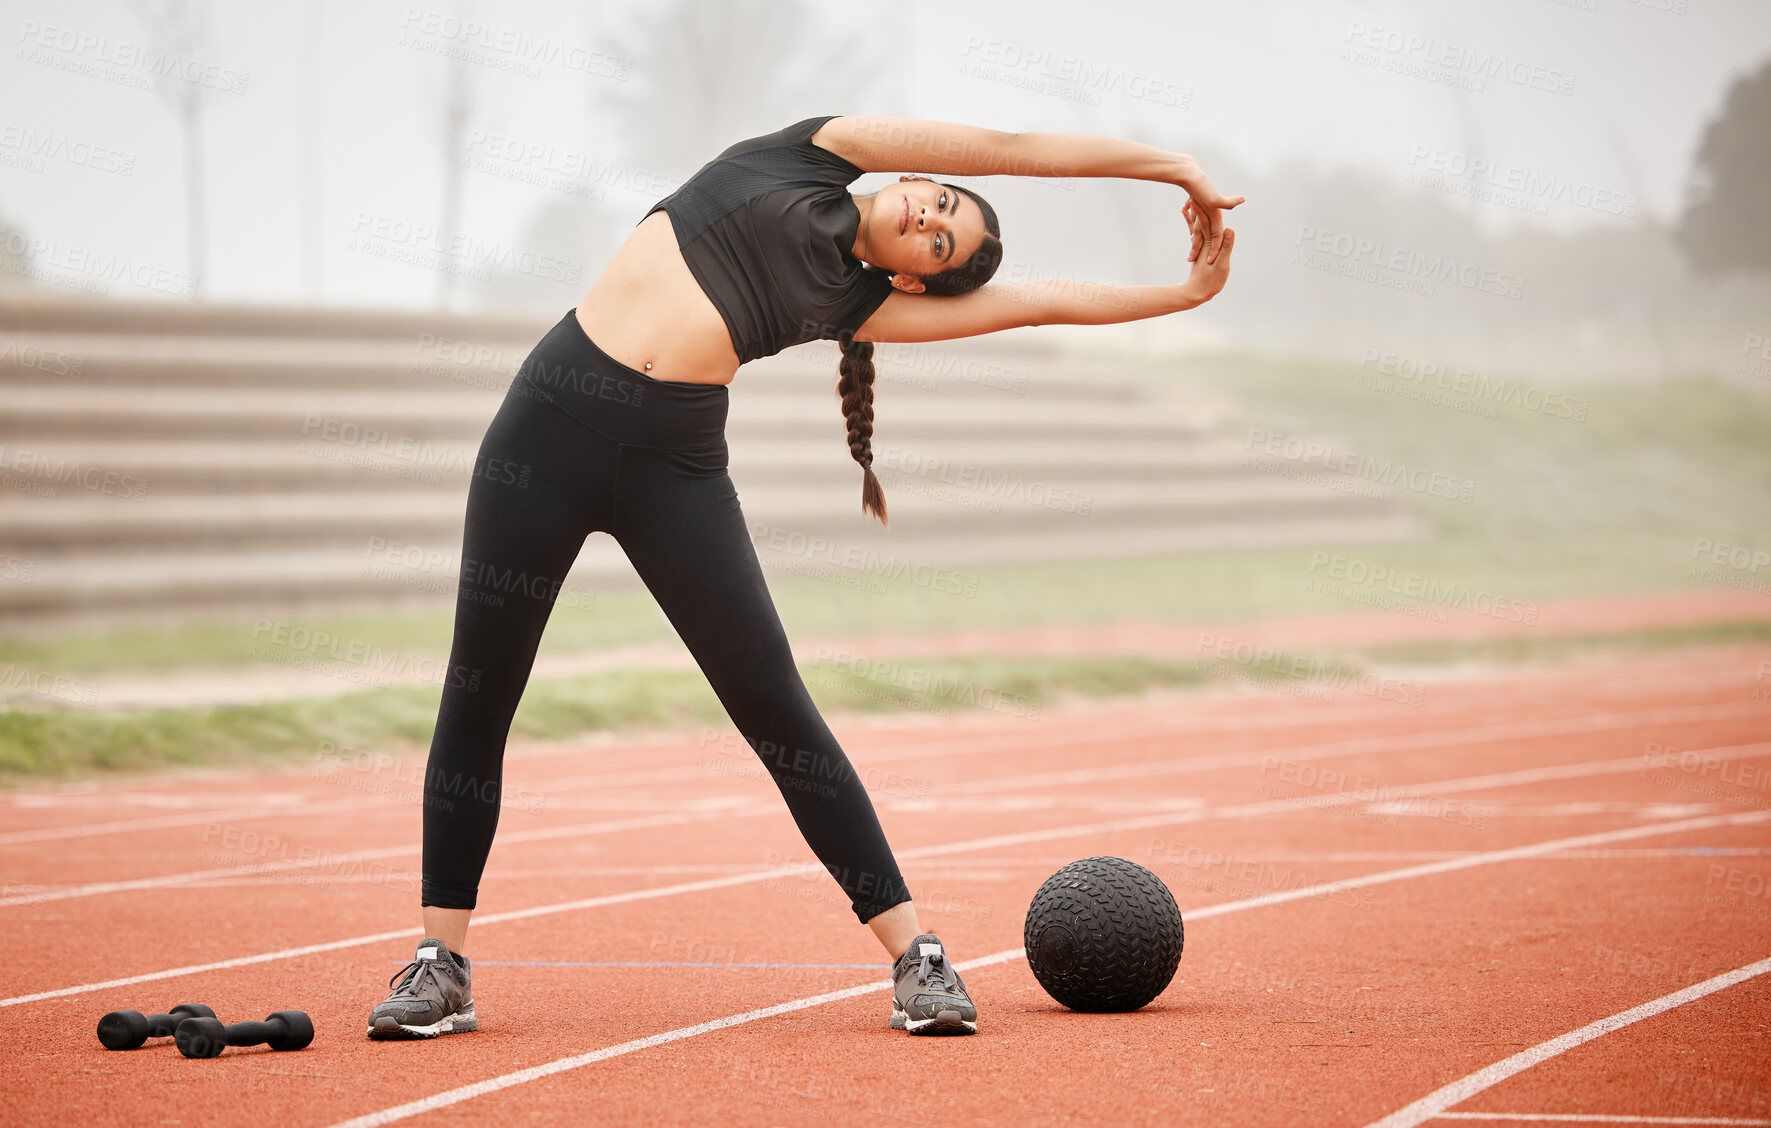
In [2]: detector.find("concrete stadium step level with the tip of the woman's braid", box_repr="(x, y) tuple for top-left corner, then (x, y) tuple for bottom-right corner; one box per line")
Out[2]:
(0, 475), (1390, 556)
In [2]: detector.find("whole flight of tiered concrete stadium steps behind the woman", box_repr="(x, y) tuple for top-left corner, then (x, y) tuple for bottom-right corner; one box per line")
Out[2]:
(0, 289), (1422, 630)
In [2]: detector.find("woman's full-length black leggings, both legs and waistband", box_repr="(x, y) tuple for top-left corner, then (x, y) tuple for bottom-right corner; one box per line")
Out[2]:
(421, 310), (910, 921)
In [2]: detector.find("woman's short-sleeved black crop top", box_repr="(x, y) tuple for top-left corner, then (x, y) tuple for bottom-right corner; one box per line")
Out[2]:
(646, 113), (891, 363)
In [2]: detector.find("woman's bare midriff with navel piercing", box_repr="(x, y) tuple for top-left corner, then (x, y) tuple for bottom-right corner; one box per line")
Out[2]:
(577, 211), (739, 384)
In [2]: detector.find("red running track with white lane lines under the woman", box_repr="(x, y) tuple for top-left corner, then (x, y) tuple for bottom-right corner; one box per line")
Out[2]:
(0, 616), (1771, 1128)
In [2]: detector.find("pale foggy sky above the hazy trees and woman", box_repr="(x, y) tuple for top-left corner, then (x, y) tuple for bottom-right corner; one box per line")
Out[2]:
(0, 0), (1771, 306)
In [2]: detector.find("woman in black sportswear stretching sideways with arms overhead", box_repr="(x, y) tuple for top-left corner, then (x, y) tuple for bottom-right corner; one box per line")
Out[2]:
(368, 117), (1241, 1038)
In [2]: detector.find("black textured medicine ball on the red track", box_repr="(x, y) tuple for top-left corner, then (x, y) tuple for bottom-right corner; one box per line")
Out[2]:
(1022, 857), (1185, 1013)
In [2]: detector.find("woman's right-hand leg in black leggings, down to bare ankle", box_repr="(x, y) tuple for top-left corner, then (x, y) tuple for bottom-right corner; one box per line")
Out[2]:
(615, 444), (916, 958)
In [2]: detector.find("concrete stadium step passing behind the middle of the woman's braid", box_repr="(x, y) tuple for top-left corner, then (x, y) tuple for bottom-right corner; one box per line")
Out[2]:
(0, 388), (1210, 446)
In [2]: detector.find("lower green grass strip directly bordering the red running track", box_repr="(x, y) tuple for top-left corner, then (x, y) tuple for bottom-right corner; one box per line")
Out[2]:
(0, 622), (1771, 783)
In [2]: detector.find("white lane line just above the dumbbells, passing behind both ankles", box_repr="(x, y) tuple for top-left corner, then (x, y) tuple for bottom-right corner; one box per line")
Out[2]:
(0, 743), (1771, 1008)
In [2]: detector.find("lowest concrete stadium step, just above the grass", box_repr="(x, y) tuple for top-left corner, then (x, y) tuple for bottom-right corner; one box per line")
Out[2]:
(0, 512), (1422, 629)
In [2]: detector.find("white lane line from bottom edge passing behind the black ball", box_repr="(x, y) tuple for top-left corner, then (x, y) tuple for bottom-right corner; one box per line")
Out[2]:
(318, 811), (1771, 1128)
